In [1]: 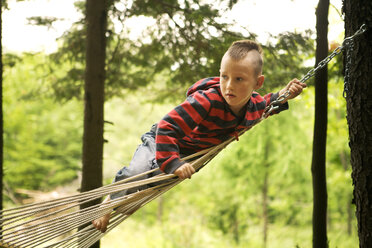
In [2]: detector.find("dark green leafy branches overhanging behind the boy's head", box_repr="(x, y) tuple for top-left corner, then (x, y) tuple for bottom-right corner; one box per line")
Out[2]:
(40, 0), (313, 101)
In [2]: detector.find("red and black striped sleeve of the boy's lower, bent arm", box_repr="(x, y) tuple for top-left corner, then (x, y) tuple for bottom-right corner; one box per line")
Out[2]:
(155, 91), (211, 173)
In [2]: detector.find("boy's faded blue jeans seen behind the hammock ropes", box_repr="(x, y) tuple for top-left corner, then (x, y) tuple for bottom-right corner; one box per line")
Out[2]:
(110, 124), (161, 199)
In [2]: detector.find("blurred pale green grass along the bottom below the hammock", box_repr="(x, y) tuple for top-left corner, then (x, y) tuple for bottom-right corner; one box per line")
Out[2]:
(101, 213), (358, 248)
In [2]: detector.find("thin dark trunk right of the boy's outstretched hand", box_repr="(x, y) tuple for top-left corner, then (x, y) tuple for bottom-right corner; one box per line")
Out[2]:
(311, 0), (329, 248)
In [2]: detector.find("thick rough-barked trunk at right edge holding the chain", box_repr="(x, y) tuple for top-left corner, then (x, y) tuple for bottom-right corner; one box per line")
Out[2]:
(343, 0), (372, 248)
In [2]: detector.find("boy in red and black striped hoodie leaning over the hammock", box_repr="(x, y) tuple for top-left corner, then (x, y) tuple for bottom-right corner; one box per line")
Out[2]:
(93, 40), (306, 232)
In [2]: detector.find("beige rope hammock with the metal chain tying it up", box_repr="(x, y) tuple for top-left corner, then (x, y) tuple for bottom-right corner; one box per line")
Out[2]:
(0, 24), (367, 248)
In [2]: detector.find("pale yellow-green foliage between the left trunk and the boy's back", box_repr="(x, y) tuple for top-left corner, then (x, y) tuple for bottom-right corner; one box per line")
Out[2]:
(104, 96), (172, 183)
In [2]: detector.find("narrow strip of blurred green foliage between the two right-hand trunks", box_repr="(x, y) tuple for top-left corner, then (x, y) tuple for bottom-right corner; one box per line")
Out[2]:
(327, 80), (354, 236)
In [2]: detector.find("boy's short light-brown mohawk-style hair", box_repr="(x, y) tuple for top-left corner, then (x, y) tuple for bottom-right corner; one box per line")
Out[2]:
(226, 40), (263, 75)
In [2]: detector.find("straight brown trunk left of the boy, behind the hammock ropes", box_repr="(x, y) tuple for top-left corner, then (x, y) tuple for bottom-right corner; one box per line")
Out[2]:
(81, 0), (107, 247)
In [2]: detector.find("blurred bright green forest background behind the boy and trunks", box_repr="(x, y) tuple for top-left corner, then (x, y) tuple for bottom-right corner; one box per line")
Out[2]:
(3, 0), (358, 247)
